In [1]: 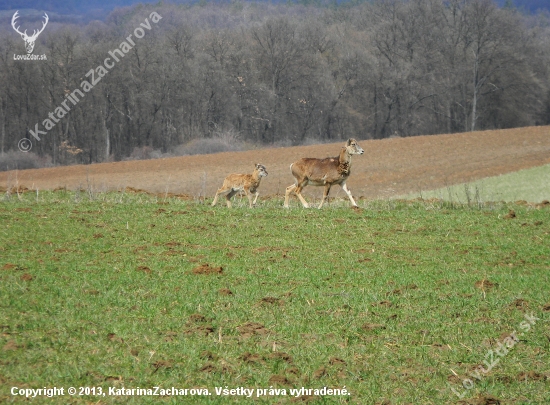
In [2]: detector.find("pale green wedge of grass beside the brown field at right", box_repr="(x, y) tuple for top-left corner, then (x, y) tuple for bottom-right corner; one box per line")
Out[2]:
(404, 165), (550, 203)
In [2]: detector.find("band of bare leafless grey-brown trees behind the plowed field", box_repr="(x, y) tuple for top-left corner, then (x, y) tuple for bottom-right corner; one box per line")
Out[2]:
(0, 0), (550, 164)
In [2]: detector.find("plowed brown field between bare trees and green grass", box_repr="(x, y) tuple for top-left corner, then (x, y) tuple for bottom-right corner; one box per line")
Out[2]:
(0, 127), (550, 199)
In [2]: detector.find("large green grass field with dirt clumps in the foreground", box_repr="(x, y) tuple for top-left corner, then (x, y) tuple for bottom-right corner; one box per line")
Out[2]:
(0, 191), (550, 404)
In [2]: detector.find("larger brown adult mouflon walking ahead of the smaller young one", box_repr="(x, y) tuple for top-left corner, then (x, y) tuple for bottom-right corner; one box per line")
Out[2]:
(284, 138), (365, 209)
